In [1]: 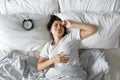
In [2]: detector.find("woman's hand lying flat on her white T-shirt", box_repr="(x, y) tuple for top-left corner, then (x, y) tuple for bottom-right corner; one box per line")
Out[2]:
(51, 52), (69, 63)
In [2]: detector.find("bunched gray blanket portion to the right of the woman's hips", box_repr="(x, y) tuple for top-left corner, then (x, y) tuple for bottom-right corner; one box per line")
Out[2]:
(80, 49), (111, 80)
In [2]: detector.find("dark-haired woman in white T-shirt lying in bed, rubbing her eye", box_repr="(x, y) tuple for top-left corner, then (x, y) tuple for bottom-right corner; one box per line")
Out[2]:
(37, 15), (97, 80)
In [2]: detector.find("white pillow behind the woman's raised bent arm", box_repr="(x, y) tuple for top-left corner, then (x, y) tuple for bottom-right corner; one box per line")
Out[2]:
(56, 12), (120, 48)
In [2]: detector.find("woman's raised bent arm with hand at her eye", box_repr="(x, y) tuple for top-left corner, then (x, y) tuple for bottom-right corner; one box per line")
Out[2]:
(63, 20), (97, 39)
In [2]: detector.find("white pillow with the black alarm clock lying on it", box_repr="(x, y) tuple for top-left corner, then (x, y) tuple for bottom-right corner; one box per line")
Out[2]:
(0, 14), (50, 51)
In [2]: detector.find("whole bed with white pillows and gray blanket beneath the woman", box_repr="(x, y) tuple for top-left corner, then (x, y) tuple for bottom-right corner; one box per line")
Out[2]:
(0, 0), (120, 80)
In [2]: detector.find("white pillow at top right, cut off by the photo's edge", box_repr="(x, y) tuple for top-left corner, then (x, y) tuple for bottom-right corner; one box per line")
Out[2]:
(59, 0), (120, 12)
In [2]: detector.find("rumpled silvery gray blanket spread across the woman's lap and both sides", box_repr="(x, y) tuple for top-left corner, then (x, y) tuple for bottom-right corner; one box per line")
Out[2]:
(0, 50), (110, 80)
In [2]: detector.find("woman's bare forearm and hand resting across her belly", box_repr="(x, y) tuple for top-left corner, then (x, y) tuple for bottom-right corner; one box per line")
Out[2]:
(37, 52), (69, 71)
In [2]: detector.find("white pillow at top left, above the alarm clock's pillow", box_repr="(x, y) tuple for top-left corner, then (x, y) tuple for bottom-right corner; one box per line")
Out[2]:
(0, 0), (59, 14)
